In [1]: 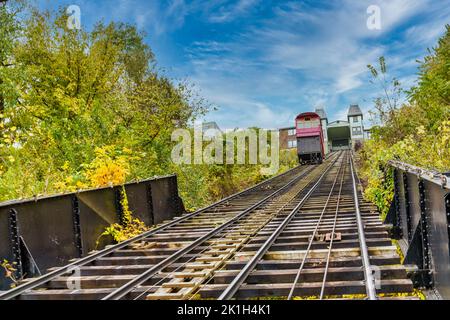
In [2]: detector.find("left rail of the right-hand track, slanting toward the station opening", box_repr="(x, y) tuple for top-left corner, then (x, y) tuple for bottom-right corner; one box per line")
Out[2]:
(218, 151), (339, 300)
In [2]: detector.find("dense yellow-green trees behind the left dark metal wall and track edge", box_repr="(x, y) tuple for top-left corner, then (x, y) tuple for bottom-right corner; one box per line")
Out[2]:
(0, 0), (295, 218)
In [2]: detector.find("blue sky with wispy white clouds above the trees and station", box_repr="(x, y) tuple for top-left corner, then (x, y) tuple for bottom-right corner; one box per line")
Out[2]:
(35, 0), (450, 129)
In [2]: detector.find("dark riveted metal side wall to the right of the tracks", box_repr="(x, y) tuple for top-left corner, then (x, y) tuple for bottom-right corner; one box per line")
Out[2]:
(386, 161), (450, 299)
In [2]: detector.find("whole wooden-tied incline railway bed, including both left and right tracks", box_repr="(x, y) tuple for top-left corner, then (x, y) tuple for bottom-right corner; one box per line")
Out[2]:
(0, 152), (413, 300)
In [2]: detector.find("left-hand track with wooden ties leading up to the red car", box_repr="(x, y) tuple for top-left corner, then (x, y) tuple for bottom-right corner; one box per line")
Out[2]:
(0, 155), (330, 299)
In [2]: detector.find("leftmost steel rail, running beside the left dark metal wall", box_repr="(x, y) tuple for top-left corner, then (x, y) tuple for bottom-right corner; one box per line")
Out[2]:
(0, 166), (306, 300)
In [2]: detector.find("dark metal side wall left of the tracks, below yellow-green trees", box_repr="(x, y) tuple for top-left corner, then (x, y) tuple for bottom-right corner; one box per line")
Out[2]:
(0, 175), (184, 290)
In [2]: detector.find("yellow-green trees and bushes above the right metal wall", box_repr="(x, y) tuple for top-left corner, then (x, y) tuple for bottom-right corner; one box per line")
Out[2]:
(361, 26), (450, 218)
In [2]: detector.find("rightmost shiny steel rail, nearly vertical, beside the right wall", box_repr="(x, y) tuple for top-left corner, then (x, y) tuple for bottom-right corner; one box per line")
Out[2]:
(350, 159), (377, 300)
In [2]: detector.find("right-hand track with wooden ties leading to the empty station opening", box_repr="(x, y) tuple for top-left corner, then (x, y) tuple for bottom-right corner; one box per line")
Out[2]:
(199, 153), (417, 300)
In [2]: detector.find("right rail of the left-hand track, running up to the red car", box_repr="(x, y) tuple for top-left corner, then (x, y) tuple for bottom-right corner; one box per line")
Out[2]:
(102, 162), (320, 300)
